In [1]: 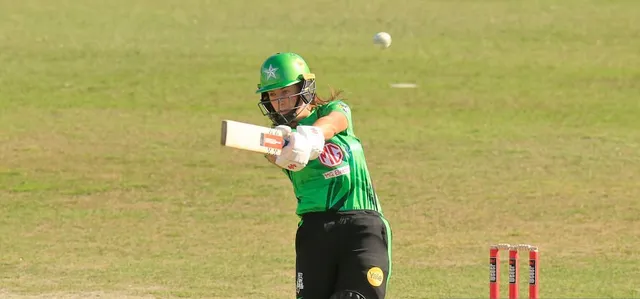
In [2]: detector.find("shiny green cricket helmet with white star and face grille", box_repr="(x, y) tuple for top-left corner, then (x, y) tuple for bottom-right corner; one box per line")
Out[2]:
(256, 52), (316, 126)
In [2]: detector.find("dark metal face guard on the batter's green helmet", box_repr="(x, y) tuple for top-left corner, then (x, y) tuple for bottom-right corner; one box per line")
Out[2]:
(258, 74), (316, 126)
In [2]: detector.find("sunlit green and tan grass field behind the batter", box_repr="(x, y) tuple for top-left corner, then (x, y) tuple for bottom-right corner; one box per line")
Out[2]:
(0, 0), (640, 299)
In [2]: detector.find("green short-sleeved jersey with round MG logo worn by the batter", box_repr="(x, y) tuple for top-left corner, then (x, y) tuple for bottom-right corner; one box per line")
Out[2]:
(283, 101), (382, 215)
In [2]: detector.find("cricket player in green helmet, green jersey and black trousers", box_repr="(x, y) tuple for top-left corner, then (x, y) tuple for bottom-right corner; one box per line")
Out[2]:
(257, 53), (391, 299)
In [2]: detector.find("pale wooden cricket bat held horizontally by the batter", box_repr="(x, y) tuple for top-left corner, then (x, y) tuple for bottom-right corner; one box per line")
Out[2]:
(220, 120), (286, 155)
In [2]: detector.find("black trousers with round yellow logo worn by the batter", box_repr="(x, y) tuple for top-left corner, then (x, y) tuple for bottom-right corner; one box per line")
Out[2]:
(296, 211), (391, 299)
